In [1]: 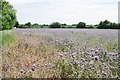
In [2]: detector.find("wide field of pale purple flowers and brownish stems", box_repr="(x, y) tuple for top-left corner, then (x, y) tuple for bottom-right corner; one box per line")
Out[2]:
(2, 29), (119, 78)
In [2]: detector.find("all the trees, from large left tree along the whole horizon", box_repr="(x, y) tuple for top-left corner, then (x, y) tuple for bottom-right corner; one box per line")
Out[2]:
(0, 0), (120, 30)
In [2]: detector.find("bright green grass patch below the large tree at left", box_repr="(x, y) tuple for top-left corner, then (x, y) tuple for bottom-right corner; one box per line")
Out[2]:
(0, 30), (15, 46)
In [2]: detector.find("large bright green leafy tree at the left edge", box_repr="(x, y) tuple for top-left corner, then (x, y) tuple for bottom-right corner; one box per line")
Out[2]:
(0, 0), (17, 30)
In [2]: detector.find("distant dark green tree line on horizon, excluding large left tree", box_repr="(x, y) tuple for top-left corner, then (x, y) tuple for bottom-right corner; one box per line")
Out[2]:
(15, 20), (120, 29)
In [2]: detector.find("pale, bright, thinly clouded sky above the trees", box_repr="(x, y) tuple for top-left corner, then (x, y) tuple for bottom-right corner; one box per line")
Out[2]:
(7, 0), (119, 24)
